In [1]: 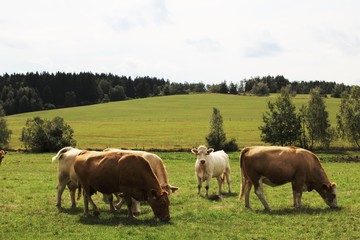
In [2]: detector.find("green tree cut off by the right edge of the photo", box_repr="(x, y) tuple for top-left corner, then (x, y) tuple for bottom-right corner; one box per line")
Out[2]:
(336, 86), (360, 148)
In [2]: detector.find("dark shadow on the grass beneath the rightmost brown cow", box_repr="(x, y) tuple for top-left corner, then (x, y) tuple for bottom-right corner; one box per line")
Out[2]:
(255, 207), (342, 216)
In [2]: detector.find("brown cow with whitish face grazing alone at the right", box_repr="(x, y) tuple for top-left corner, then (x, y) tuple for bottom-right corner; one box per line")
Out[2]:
(239, 146), (337, 211)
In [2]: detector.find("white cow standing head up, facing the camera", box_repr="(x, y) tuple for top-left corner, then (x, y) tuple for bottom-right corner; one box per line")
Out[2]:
(191, 145), (231, 197)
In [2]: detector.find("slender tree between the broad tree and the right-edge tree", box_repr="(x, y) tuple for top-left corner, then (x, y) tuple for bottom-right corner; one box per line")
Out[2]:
(305, 87), (332, 148)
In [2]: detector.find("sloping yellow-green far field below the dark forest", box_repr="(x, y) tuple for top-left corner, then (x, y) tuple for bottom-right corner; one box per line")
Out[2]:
(6, 94), (344, 150)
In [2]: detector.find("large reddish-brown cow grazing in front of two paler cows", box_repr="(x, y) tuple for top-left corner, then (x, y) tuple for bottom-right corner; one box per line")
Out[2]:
(71, 151), (170, 221)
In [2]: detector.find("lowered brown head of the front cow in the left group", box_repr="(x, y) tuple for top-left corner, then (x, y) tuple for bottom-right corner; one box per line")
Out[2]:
(147, 189), (170, 222)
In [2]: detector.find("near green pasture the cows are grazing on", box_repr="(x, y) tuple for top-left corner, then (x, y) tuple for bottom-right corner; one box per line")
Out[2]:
(0, 152), (360, 239)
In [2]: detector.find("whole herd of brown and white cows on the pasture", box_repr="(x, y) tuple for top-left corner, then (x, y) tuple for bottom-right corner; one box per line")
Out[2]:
(0, 145), (337, 221)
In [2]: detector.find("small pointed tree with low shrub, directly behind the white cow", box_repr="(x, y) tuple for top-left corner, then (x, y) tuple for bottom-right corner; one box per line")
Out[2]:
(205, 108), (239, 151)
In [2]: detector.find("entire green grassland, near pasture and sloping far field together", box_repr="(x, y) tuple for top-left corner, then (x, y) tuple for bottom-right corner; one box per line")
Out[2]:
(0, 94), (360, 239)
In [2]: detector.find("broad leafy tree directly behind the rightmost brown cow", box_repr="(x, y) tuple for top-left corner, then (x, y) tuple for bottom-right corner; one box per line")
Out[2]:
(259, 87), (301, 146)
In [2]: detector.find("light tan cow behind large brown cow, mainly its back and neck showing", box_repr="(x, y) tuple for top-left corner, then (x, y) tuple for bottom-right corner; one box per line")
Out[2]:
(103, 148), (179, 214)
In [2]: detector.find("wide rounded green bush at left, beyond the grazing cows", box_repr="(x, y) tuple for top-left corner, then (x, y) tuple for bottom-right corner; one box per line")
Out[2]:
(20, 117), (76, 152)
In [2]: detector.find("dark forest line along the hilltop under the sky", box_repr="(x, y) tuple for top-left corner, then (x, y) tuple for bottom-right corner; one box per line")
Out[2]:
(0, 72), (350, 115)
